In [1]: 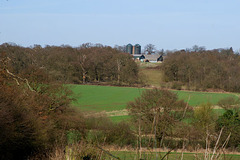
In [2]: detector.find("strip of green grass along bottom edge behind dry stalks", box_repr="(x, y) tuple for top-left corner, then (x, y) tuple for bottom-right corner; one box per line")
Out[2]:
(109, 151), (240, 160)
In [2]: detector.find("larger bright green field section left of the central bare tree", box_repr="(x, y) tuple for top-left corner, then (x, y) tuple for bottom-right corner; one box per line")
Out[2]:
(70, 85), (144, 112)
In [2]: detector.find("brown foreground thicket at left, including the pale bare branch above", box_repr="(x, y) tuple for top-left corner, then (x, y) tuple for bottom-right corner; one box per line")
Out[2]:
(0, 57), (84, 160)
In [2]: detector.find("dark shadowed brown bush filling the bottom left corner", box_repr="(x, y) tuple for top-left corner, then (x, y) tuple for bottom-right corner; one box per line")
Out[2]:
(0, 86), (49, 159)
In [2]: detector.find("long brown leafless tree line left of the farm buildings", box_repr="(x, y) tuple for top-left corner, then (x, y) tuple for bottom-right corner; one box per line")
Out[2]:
(0, 43), (140, 85)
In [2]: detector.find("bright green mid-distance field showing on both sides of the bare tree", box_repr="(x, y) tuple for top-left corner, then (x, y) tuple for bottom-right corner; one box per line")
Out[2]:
(70, 85), (237, 112)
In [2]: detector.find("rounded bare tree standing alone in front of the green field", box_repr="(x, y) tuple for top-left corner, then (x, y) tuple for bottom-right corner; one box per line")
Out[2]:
(127, 89), (186, 147)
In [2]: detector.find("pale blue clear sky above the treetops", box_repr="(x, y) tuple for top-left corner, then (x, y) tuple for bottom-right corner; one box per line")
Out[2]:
(0, 0), (240, 50)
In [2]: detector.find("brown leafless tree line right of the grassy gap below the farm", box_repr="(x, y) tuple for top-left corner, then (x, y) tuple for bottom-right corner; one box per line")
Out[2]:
(162, 48), (240, 92)
